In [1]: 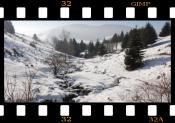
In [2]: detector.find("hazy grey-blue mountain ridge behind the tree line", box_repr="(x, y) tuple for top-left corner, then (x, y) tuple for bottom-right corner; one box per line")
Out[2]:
(38, 24), (132, 42)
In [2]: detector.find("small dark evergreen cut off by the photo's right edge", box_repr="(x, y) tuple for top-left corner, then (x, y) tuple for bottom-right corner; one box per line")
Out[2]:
(159, 22), (171, 37)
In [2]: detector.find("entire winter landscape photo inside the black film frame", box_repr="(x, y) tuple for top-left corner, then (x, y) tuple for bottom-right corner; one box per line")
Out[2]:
(4, 20), (171, 103)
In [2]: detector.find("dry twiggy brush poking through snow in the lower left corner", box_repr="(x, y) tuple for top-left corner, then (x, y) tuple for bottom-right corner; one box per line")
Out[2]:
(4, 68), (36, 102)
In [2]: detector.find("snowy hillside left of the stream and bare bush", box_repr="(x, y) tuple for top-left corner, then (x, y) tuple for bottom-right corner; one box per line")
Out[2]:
(4, 34), (68, 101)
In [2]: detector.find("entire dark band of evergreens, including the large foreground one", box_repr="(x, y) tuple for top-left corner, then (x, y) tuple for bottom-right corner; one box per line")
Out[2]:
(54, 22), (171, 71)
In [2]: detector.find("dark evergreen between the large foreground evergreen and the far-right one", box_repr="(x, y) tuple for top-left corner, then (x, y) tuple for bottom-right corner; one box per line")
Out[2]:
(141, 23), (157, 47)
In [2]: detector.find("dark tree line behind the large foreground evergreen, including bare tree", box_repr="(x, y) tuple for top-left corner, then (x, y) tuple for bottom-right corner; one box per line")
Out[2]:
(52, 22), (171, 58)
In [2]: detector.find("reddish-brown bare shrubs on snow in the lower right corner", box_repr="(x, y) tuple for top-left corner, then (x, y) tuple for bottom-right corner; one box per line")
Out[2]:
(132, 73), (171, 102)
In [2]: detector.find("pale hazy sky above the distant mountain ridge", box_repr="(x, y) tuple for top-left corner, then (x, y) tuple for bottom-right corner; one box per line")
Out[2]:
(12, 20), (170, 35)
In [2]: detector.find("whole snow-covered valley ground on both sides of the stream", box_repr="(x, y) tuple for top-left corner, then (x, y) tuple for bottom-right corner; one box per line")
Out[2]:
(4, 34), (171, 102)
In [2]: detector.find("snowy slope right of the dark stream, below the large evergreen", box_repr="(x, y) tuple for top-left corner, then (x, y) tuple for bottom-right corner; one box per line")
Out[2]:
(71, 36), (171, 102)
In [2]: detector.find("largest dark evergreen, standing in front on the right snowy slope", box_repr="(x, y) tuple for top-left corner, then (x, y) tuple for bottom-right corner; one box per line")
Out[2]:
(124, 29), (143, 71)
